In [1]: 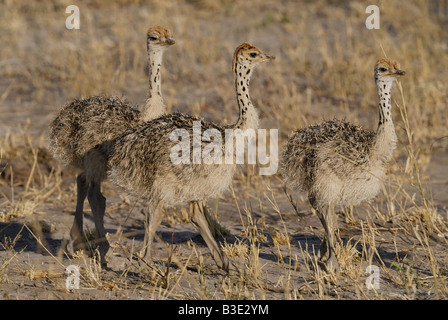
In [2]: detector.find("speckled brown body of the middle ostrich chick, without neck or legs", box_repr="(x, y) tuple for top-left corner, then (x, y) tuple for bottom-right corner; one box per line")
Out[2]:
(103, 113), (235, 206)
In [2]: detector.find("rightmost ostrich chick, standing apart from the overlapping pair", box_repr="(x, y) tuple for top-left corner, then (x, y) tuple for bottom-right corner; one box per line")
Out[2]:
(280, 59), (405, 271)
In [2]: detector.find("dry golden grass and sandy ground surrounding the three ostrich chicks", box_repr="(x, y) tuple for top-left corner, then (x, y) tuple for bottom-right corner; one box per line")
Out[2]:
(0, 0), (448, 299)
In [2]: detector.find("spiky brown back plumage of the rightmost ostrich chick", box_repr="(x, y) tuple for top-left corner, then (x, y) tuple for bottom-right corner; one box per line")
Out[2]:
(281, 120), (375, 198)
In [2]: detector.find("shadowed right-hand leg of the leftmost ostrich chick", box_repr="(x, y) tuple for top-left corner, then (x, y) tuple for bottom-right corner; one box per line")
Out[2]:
(87, 181), (110, 263)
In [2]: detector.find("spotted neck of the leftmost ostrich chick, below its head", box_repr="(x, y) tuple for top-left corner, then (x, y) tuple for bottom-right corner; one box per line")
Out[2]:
(140, 49), (165, 121)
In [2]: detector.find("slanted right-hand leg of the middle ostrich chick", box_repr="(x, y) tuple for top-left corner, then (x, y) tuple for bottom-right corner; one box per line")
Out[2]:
(190, 201), (229, 271)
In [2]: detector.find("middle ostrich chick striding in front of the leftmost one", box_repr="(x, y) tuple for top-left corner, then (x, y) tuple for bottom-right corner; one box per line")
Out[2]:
(97, 43), (274, 270)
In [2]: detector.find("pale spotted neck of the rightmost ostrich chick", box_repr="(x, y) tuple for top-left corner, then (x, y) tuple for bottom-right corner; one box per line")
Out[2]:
(374, 79), (397, 162)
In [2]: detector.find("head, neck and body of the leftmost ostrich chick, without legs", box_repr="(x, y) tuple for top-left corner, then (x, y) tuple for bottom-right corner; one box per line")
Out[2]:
(49, 26), (174, 174)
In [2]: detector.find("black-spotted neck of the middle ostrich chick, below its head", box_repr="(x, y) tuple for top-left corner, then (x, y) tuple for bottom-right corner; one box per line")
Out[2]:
(234, 65), (258, 130)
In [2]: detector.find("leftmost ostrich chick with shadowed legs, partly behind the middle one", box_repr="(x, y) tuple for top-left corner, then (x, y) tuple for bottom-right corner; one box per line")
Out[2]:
(49, 26), (174, 259)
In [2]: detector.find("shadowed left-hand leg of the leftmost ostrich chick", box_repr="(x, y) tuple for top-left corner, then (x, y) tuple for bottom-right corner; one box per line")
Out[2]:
(67, 172), (89, 254)
